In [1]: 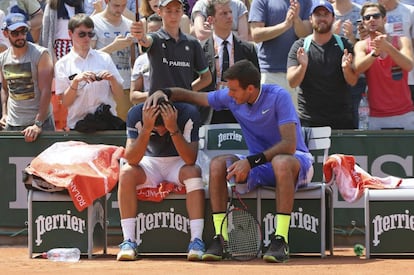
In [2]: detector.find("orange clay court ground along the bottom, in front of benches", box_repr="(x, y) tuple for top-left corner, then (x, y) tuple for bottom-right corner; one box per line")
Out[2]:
(0, 246), (414, 275)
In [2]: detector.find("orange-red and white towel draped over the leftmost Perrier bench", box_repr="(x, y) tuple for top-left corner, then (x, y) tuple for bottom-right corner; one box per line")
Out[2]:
(26, 141), (124, 211)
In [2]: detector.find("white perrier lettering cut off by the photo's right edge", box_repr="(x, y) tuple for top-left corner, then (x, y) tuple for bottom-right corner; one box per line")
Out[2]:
(372, 209), (414, 246)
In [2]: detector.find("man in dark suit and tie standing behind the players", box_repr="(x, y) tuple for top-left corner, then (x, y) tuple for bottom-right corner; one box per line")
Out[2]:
(201, 0), (259, 124)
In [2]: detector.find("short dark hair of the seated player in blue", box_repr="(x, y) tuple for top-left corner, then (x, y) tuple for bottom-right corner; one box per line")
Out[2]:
(224, 59), (260, 89)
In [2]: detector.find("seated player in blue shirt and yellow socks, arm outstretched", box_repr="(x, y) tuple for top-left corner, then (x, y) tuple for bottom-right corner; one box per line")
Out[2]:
(144, 60), (313, 263)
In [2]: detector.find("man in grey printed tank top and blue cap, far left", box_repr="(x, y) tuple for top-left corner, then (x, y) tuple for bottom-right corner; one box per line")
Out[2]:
(0, 13), (55, 142)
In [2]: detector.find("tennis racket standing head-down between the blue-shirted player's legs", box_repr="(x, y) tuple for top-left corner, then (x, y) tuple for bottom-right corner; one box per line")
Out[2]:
(220, 160), (262, 261)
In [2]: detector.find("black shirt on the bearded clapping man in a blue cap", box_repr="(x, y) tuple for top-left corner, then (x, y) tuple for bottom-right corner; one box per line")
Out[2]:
(287, 36), (353, 125)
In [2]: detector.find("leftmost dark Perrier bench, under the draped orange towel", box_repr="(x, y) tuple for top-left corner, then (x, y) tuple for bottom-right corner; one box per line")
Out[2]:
(28, 190), (107, 259)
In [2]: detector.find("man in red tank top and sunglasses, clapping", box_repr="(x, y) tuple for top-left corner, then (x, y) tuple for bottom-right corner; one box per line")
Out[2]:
(354, 3), (414, 130)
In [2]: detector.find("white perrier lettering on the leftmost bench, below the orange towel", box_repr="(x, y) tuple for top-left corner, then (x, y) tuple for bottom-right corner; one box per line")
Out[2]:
(35, 210), (86, 246)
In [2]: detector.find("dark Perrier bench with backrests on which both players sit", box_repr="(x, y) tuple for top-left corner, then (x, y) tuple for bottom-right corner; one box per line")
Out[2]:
(137, 124), (333, 257)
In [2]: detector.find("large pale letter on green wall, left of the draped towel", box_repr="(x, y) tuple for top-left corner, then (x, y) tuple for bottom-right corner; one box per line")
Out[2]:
(9, 157), (34, 209)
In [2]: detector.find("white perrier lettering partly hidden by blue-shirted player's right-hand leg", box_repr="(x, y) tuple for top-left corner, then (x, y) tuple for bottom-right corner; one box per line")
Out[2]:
(263, 207), (319, 246)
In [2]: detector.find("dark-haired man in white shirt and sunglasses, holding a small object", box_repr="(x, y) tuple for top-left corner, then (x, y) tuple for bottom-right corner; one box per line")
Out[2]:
(55, 13), (124, 130)
